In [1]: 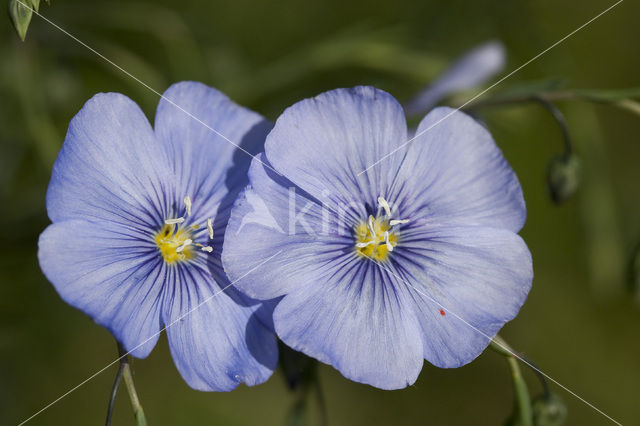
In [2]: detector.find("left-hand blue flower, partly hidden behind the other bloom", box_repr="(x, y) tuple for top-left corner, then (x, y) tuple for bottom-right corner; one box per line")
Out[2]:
(38, 82), (277, 391)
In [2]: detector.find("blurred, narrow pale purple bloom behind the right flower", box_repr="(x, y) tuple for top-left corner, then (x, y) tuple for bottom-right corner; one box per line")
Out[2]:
(405, 41), (506, 116)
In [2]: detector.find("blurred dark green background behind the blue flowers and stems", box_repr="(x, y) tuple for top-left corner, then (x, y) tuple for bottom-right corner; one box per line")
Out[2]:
(0, 0), (640, 426)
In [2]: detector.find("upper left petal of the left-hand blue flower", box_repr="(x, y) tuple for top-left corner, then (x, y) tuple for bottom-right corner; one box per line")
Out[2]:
(47, 93), (173, 229)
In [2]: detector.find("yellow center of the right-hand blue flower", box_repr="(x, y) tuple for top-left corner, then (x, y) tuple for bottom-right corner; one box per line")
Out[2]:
(354, 216), (398, 261)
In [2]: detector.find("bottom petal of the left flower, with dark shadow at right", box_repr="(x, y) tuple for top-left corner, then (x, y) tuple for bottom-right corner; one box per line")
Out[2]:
(163, 267), (278, 391)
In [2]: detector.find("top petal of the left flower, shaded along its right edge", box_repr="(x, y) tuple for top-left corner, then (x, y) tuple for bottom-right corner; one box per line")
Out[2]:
(155, 81), (272, 223)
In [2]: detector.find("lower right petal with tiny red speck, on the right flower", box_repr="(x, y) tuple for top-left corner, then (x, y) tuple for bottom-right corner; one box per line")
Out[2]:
(393, 227), (533, 367)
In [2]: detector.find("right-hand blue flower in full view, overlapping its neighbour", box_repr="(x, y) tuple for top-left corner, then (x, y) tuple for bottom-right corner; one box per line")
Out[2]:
(222, 87), (533, 389)
